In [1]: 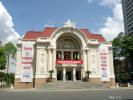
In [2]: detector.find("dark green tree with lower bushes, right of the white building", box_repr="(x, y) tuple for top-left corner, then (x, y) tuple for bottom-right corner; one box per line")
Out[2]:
(112, 33), (133, 82)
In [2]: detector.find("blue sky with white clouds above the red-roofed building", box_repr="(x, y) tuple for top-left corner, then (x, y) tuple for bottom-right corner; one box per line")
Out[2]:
(0, 0), (123, 42)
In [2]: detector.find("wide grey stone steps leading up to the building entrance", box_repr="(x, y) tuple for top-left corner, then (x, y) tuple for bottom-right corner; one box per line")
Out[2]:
(44, 81), (107, 90)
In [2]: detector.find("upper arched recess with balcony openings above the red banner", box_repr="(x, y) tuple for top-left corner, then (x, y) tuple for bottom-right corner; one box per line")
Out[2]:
(56, 33), (82, 60)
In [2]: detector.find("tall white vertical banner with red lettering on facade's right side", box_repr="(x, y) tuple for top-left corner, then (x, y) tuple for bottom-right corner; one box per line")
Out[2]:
(99, 46), (110, 81)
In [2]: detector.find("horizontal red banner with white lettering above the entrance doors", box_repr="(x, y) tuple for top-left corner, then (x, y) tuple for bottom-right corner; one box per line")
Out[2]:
(56, 60), (83, 64)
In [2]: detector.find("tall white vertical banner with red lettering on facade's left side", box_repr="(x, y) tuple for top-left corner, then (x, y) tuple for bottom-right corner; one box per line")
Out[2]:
(20, 43), (33, 82)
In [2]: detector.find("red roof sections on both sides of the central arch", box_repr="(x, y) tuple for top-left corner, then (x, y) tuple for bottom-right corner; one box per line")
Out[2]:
(23, 27), (106, 42)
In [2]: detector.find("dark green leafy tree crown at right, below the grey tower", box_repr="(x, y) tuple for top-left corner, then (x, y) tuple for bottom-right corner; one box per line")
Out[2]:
(113, 33), (133, 58)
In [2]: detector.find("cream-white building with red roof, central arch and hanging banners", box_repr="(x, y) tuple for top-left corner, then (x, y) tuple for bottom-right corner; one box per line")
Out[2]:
(15, 21), (115, 88)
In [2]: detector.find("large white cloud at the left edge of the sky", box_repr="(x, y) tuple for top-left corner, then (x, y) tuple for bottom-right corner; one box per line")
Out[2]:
(0, 1), (20, 43)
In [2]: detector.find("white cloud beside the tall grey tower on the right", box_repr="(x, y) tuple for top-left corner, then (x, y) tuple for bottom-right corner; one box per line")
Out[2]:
(98, 0), (124, 41)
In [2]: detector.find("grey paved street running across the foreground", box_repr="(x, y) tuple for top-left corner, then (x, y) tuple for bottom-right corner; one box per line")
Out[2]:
(0, 89), (133, 100)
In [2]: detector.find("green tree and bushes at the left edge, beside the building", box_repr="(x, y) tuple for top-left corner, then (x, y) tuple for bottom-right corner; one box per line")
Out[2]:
(0, 42), (17, 88)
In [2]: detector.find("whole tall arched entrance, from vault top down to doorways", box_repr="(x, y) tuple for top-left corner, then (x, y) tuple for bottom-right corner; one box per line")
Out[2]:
(56, 33), (82, 81)
